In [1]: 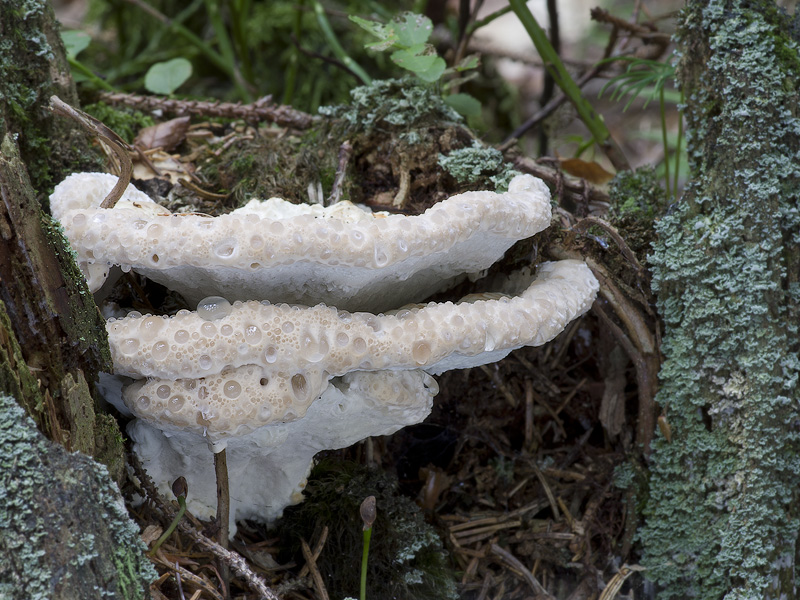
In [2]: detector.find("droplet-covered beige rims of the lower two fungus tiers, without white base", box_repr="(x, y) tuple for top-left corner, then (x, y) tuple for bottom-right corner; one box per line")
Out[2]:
(107, 260), (598, 439)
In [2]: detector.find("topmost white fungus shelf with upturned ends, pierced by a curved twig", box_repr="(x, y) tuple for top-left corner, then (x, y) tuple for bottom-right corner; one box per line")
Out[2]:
(50, 173), (550, 311)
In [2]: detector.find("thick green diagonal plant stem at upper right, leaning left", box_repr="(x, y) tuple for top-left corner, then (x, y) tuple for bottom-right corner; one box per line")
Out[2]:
(509, 0), (630, 171)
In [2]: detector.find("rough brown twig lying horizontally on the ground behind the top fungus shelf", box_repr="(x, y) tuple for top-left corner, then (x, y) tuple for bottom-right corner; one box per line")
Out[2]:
(100, 92), (315, 129)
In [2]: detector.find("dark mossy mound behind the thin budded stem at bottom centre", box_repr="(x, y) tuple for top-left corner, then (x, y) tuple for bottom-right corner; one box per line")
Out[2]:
(279, 462), (458, 600)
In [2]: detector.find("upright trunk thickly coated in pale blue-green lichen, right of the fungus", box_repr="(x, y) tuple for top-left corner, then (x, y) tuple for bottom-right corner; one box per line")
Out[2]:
(640, 0), (800, 599)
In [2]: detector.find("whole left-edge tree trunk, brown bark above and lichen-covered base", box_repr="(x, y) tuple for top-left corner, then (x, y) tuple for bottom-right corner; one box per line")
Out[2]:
(0, 0), (156, 600)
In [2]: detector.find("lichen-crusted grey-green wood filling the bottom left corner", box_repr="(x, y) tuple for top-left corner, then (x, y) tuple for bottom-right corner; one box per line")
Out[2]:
(0, 395), (157, 600)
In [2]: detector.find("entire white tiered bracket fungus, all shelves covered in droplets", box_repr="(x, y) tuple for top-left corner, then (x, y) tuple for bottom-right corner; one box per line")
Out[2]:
(51, 174), (598, 521)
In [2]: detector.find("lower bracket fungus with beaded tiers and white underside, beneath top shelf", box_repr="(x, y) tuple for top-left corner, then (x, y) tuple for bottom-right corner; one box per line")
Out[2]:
(107, 260), (598, 519)
